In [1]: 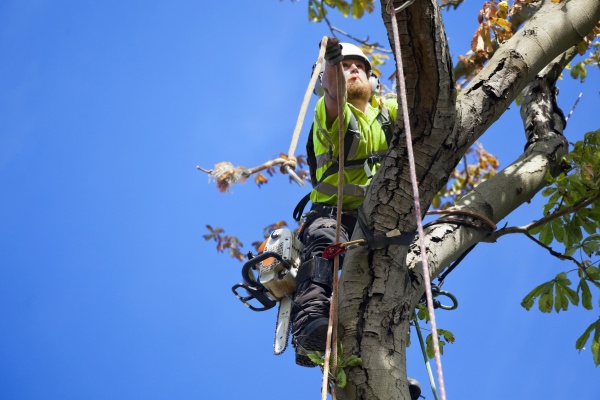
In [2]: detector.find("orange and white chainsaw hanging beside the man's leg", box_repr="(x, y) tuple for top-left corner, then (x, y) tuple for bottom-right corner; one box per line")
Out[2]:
(231, 228), (302, 355)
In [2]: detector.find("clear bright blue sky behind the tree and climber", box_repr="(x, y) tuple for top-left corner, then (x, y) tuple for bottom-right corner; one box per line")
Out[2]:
(0, 0), (600, 400)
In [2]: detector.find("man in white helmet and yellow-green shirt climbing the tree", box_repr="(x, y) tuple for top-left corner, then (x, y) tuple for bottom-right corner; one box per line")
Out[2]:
(293, 38), (398, 367)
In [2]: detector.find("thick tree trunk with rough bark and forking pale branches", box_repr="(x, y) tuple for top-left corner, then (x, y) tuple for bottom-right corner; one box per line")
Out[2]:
(339, 0), (600, 400)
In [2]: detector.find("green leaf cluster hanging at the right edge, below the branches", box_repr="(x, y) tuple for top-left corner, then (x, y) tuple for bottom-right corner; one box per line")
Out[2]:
(521, 130), (600, 365)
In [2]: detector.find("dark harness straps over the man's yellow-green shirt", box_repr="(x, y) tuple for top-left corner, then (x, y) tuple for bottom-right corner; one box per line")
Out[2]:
(293, 106), (394, 221)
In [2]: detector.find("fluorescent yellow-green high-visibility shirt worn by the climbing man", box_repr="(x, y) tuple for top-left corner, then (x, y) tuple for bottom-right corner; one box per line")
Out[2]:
(310, 98), (398, 211)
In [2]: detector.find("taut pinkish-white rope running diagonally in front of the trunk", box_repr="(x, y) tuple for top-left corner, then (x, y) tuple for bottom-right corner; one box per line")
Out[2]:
(386, 0), (446, 400)
